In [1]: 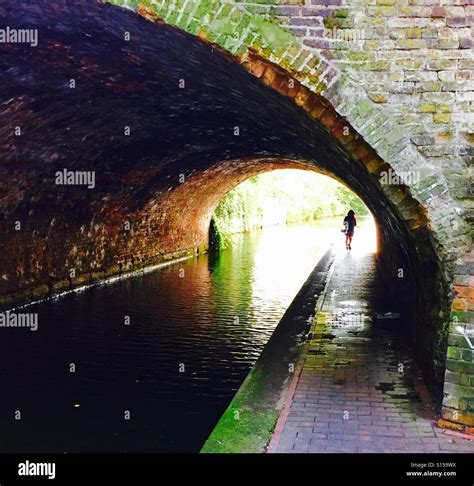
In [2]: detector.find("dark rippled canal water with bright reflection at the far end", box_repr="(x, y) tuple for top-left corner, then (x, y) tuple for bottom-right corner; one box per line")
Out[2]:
(0, 221), (343, 452)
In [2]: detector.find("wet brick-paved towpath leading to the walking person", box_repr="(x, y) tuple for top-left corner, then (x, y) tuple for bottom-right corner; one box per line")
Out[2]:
(268, 252), (474, 452)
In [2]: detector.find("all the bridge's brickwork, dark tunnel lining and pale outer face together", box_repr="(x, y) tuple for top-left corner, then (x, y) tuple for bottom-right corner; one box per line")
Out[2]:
(0, 0), (474, 430)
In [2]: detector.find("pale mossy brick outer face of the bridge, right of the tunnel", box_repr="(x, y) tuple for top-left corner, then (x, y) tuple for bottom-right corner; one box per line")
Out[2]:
(109, 0), (474, 423)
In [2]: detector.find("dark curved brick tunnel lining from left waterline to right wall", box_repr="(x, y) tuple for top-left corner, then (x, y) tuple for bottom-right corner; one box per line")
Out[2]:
(0, 0), (456, 410)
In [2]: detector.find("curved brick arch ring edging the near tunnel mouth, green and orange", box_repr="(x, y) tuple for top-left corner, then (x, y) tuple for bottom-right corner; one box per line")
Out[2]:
(126, 0), (474, 425)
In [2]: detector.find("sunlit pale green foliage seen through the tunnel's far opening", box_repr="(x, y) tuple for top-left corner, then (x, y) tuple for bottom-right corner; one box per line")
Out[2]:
(210, 169), (368, 249)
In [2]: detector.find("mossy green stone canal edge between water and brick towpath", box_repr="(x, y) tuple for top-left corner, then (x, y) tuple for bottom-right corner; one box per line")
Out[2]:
(201, 247), (335, 453)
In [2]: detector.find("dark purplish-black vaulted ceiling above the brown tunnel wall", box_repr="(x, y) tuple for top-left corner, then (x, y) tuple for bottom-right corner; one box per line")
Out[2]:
(0, 0), (384, 213)
